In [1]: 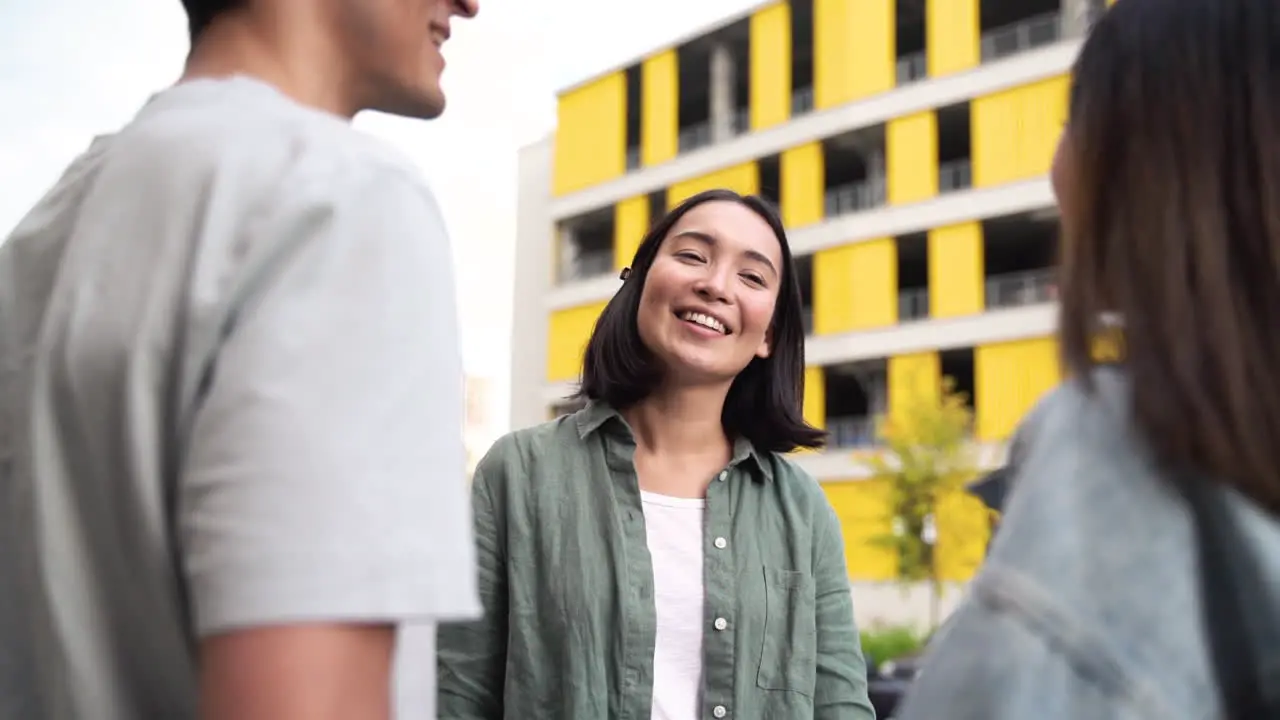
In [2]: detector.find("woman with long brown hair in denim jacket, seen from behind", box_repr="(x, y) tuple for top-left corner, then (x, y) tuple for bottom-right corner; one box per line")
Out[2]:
(901, 0), (1280, 720)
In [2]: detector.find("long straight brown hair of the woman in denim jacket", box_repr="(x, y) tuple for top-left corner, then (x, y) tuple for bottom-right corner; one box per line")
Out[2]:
(1060, 0), (1280, 512)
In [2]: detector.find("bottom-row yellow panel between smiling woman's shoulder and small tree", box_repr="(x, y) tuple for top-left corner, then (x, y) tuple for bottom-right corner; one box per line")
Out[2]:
(822, 480), (897, 582)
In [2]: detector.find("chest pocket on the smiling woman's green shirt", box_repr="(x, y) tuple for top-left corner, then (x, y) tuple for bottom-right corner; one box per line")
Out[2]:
(755, 568), (818, 697)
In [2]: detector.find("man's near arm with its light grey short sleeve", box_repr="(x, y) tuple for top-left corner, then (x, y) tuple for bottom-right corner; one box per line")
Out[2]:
(178, 169), (479, 720)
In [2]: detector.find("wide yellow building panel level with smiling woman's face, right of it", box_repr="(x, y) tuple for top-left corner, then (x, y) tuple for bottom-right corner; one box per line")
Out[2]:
(813, 237), (897, 334)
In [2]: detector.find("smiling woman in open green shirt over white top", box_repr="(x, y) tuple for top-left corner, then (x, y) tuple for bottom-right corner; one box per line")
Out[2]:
(439, 190), (874, 720)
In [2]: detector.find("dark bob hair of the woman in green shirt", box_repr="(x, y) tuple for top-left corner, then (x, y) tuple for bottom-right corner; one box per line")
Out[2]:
(577, 190), (827, 452)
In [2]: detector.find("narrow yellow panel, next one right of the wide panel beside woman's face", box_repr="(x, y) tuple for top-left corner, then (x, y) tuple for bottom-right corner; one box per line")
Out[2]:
(929, 222), (986, 318)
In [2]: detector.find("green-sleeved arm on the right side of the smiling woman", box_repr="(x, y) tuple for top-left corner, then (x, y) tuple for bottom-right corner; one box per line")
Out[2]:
(813, 496), (876, 720)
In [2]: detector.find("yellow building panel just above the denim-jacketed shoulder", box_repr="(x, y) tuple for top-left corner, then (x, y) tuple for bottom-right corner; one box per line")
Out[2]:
(974, 337), (1061, 442)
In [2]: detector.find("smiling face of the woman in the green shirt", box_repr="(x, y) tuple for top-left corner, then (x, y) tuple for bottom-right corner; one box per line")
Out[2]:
(636, 196), (782, 384)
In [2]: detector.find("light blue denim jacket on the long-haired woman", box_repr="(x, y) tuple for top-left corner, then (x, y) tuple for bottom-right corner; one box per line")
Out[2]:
(899, 370), (1280, 720)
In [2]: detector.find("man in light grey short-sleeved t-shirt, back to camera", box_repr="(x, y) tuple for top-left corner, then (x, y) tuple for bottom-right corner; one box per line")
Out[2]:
(0, 0), (479, 720)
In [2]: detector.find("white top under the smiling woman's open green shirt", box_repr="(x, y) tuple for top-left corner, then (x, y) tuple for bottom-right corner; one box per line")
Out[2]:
(640, 491), (707, 720)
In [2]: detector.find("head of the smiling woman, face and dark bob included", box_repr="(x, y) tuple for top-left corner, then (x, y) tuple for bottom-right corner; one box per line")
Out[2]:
(579, 190), (824, 452)
